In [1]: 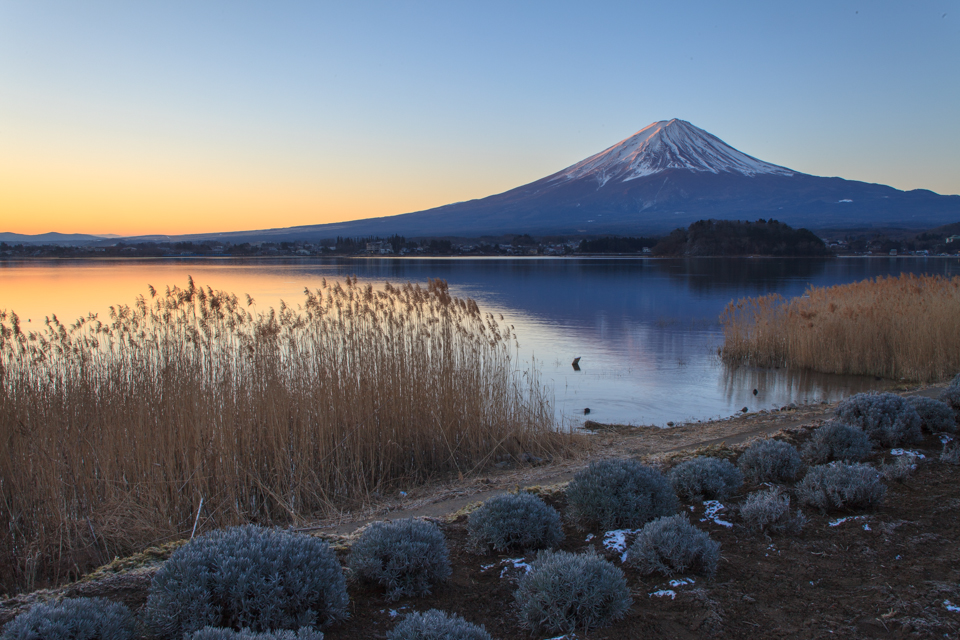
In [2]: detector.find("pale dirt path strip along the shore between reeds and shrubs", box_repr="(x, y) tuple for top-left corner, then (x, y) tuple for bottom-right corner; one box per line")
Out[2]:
(0, 381), (947, 626)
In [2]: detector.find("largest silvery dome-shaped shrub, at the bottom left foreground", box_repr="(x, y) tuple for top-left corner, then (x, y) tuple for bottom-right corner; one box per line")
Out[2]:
(144, 525), (348, 640)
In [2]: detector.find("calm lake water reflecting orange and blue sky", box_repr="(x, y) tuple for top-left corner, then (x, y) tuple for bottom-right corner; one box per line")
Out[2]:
(0, 257), (960, 426)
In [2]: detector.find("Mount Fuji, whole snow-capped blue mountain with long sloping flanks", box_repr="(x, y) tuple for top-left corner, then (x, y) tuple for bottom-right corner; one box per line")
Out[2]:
(139, 119), (960, 241)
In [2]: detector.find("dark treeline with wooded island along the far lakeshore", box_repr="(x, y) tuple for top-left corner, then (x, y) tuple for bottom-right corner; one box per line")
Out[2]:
(7, 219), (960, 259)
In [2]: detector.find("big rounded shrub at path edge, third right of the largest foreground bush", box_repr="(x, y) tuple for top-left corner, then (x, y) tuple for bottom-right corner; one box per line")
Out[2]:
(566, 460), (677, 529)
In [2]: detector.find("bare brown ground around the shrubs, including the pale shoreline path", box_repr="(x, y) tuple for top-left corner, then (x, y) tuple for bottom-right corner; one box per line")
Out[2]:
(0, 387), (960, 640)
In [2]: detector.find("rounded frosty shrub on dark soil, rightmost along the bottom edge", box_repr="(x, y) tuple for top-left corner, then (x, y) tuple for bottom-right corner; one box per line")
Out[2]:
(516, 551), (632, 633)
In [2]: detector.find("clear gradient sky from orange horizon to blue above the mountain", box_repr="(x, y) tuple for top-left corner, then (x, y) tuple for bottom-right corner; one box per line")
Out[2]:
(0, 0), (960, 235)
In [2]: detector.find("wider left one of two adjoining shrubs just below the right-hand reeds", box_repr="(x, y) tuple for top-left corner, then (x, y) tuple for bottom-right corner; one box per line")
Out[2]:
(837, 393), (923, 447)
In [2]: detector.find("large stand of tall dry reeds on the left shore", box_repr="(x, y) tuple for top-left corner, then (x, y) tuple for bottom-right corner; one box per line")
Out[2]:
(0, 278), (569, 590)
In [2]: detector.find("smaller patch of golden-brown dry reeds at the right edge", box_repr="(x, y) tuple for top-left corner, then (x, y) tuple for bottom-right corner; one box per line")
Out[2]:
(720, 274), (960, 382)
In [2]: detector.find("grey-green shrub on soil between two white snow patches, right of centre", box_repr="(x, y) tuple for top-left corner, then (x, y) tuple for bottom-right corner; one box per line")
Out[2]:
(626, 513), (720, 576)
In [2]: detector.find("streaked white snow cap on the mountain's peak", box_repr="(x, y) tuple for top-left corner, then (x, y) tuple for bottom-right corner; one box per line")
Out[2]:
(549, 119), (794, 187)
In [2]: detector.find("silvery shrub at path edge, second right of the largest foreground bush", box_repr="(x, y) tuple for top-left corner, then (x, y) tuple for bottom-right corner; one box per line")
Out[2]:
(467, 492), (563, 552)
